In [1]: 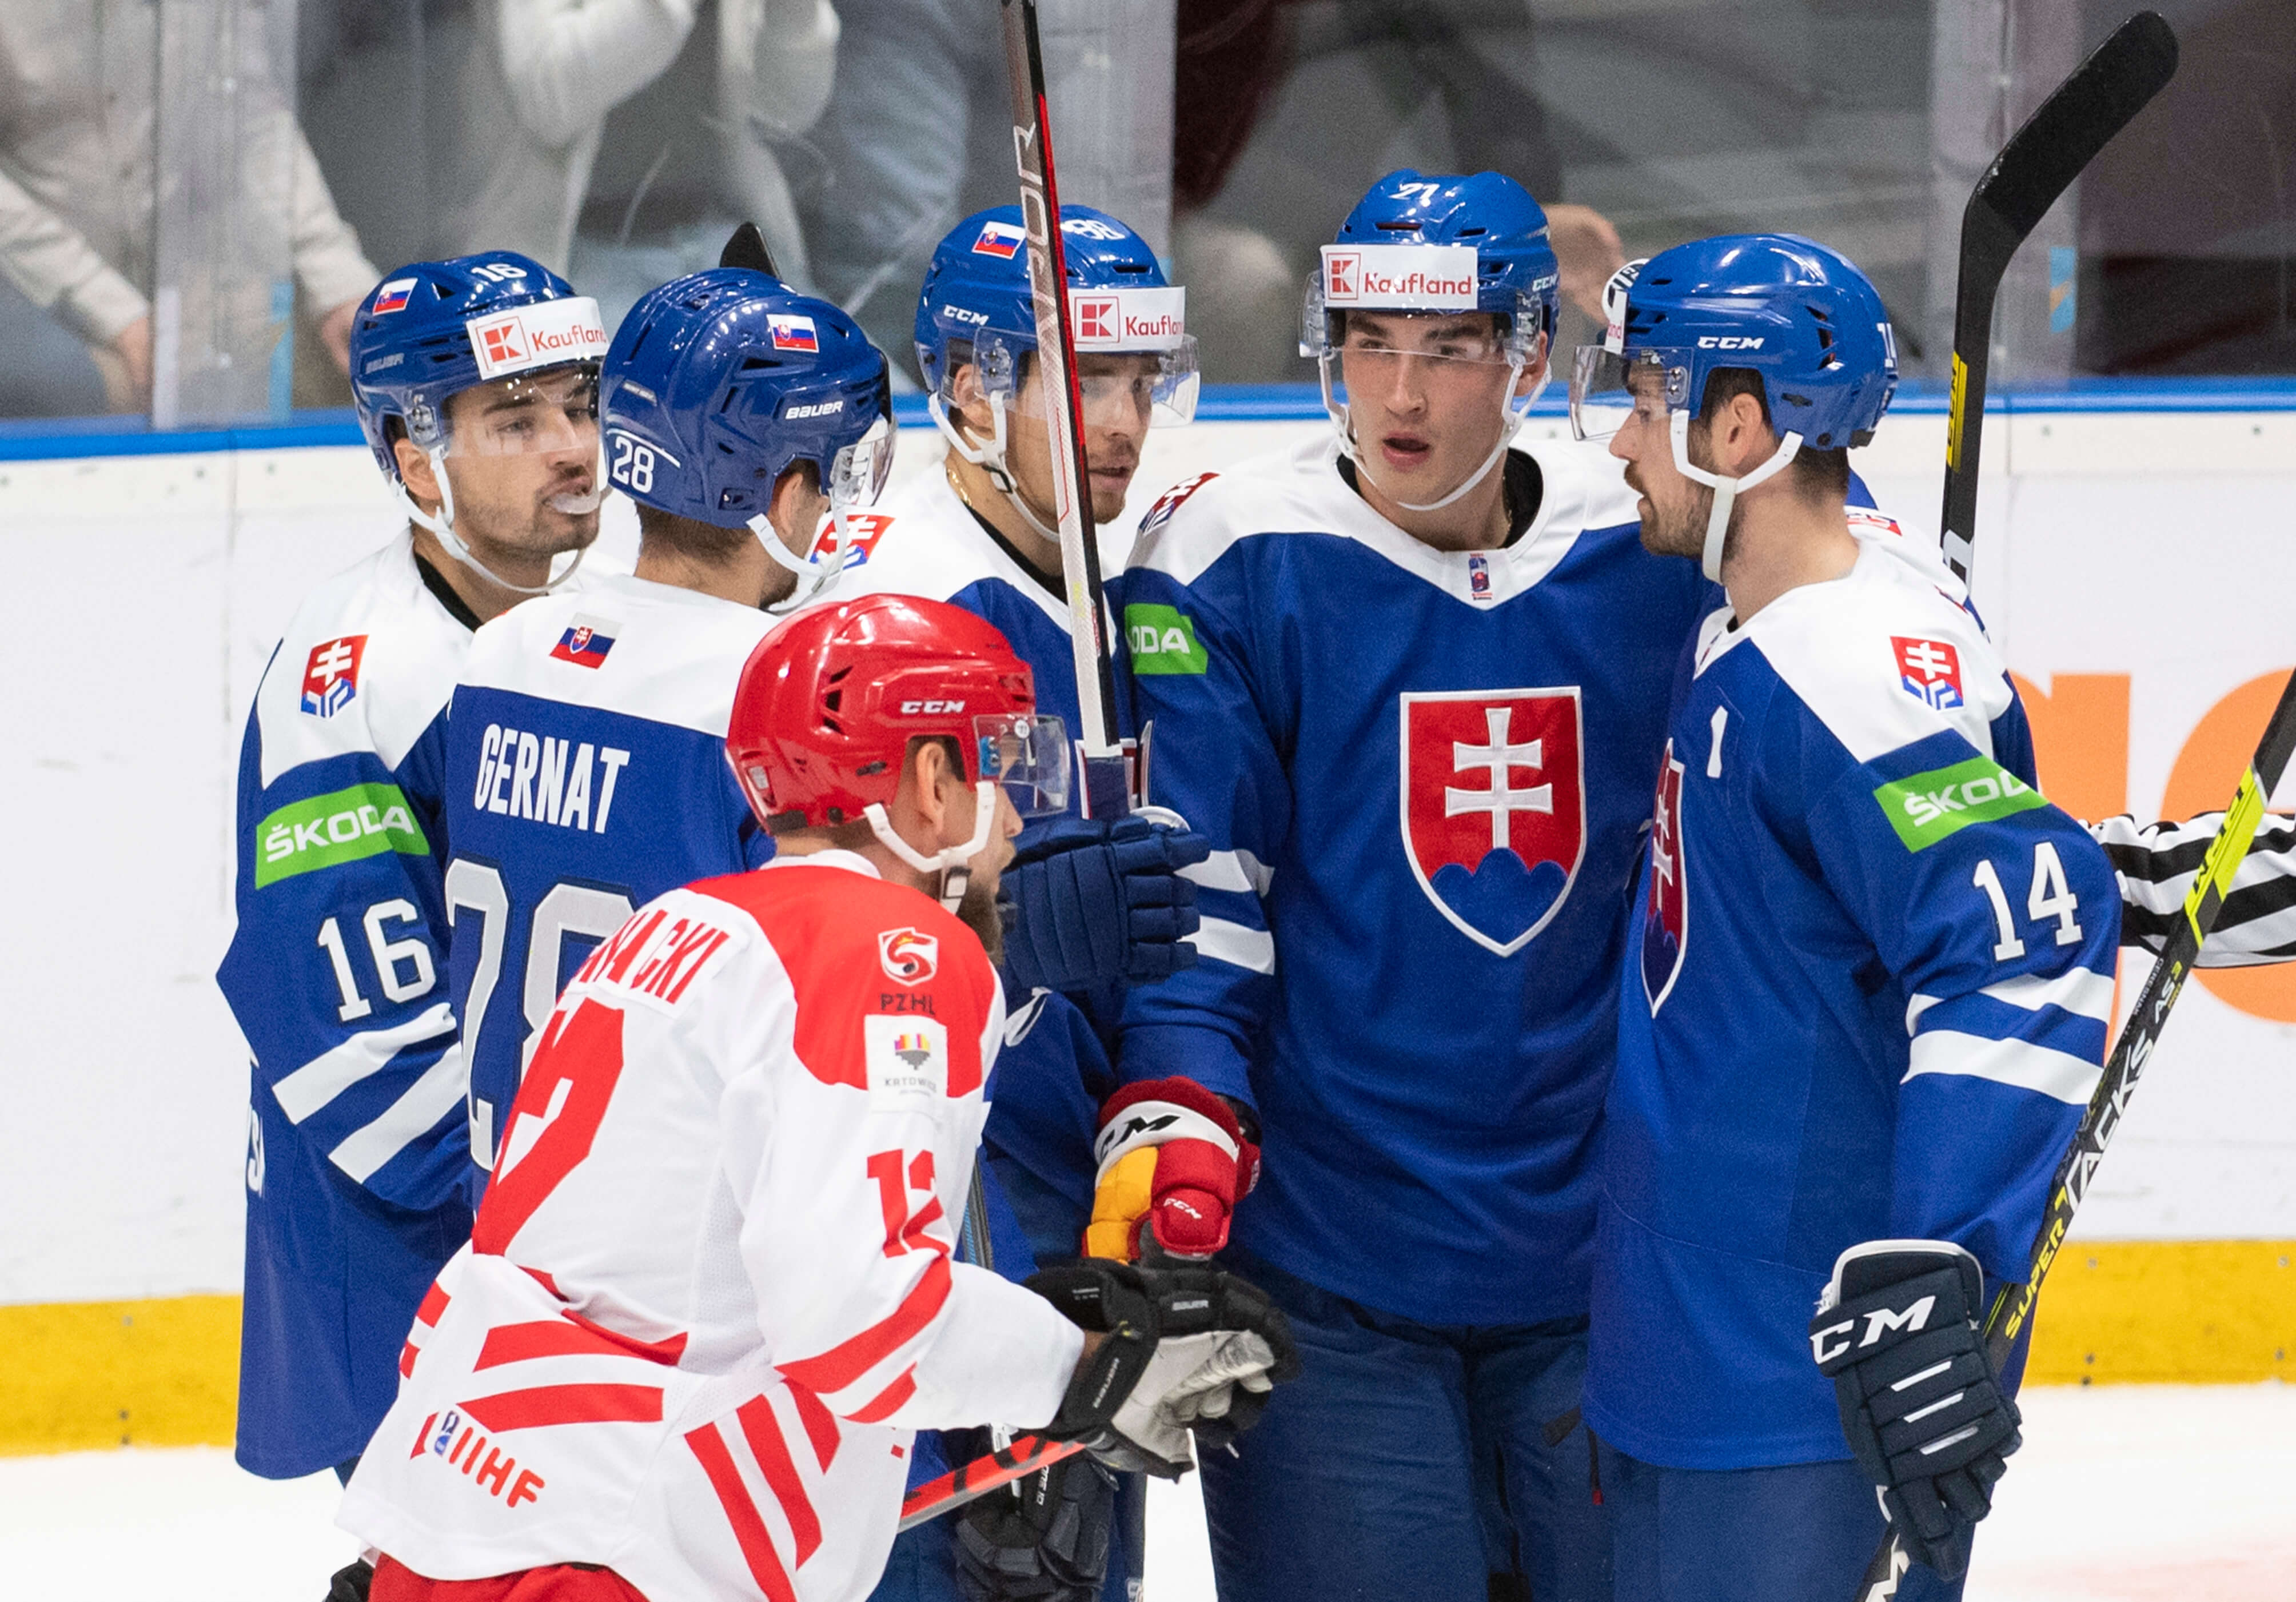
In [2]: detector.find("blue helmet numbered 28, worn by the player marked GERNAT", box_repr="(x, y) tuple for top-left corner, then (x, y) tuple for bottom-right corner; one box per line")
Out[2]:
(599, 266), (893, 606)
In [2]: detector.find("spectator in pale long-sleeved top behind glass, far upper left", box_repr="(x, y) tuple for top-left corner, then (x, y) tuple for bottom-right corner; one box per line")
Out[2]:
(0, 0), (377, 411)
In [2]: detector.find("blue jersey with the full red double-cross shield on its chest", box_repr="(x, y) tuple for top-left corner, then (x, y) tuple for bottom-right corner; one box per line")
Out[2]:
(1121, 441), (1708, 1324)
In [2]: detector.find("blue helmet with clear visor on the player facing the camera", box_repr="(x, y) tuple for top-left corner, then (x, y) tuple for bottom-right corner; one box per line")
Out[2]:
(1300, 168), (1561, 512)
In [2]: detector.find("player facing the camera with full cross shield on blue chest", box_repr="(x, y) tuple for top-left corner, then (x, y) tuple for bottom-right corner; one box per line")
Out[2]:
(1111, 172), (1706, 1602)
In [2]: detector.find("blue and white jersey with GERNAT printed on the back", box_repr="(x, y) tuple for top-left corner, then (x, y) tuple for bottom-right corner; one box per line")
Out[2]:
(445, 576), (774, 1182)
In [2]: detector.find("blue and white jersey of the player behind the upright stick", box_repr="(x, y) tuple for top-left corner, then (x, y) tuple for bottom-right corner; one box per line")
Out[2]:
(829, 471), (1132, 1272)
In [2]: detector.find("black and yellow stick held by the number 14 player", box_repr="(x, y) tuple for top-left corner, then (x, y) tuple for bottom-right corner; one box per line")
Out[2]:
(1855, 672), (2296, 1602)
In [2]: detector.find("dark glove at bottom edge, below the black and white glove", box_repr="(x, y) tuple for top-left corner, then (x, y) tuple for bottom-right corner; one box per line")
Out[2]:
(958, 1453), (1116, 1602)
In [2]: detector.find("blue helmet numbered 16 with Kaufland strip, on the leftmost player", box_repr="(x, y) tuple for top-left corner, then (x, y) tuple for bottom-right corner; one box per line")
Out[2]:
(351, 250), (606, 595)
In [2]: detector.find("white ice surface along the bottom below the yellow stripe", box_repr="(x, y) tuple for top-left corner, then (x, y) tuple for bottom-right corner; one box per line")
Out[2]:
(0, 1384), (2296, 1602)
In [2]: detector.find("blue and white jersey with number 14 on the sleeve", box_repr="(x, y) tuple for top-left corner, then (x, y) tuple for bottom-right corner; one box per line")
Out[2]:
(1584, 541), (2122, 1469)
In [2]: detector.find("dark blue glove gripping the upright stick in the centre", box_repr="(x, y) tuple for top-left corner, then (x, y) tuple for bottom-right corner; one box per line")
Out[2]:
(999, 817), (1212, 991)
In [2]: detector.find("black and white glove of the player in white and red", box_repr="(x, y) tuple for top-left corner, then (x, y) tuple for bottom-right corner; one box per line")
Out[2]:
(1029, 1258), (1300, 1480)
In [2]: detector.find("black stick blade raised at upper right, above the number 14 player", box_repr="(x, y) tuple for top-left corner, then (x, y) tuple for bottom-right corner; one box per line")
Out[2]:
(1938, 11), (2177, 581)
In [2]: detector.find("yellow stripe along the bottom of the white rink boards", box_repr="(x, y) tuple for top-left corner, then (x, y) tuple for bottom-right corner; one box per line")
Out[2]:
(0, 1242), (2296, 1455)
